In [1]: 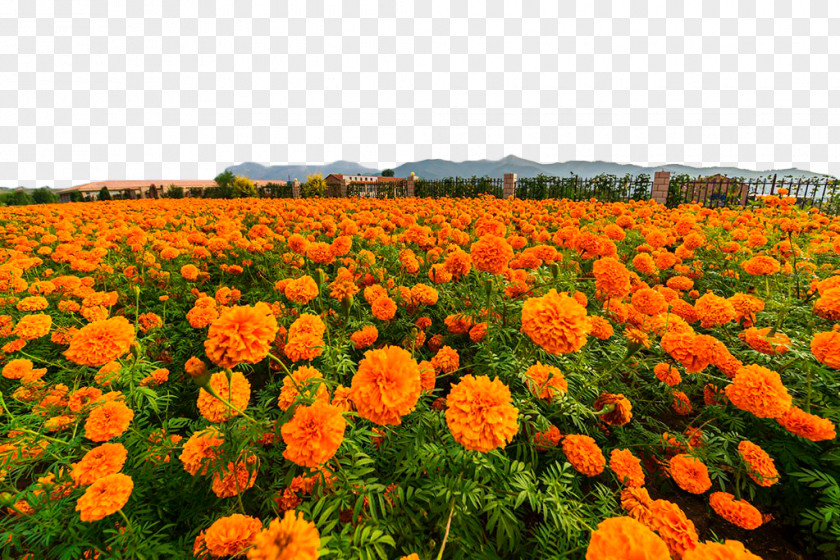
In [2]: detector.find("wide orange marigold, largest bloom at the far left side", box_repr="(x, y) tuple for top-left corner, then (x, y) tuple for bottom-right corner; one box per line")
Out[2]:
(64, 317), (135, 367)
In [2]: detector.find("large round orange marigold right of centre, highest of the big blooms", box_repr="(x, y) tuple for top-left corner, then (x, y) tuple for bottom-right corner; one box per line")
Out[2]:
(522, 289), (589, 355)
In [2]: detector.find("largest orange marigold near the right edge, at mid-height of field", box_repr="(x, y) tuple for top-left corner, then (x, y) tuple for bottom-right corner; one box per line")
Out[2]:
(726, 364), (793, 418)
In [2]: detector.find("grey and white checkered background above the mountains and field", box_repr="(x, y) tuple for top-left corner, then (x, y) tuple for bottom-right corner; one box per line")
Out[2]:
(0, 0), (840, 187)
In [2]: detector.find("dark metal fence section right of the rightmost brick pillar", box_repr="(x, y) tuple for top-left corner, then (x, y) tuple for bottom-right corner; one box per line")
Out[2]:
(666, 175), (840, 214)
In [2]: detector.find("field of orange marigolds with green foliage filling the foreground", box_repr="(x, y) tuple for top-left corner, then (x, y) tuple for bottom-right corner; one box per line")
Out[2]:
(0, 192), (840, 560)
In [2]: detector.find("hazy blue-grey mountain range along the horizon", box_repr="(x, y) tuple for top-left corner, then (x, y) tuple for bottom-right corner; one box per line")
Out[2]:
(227, 155), (823, 181)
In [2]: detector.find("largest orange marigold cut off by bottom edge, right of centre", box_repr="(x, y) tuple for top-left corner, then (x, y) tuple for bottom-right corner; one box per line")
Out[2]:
(586, 517), (671, 560)
